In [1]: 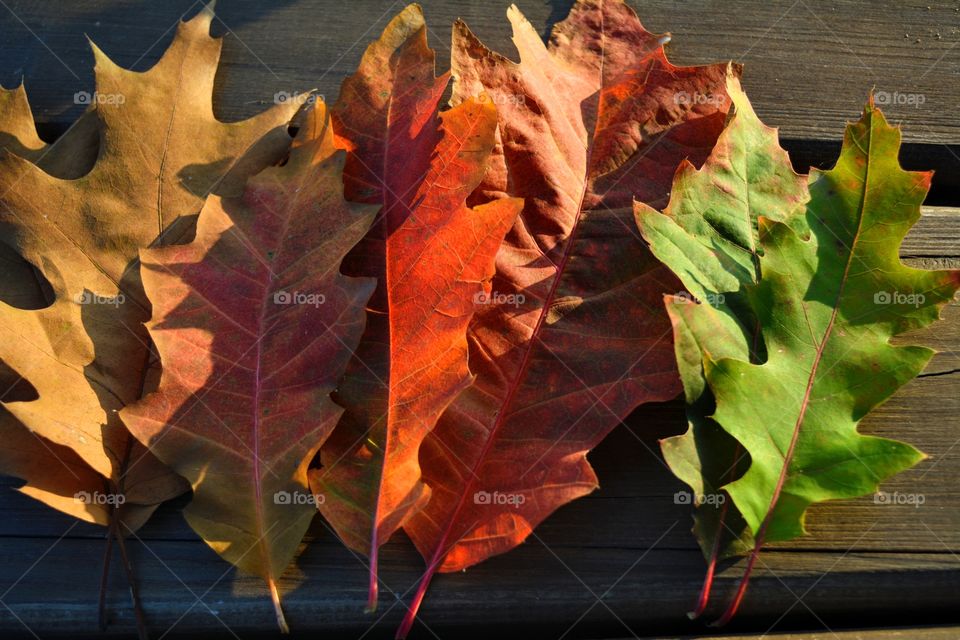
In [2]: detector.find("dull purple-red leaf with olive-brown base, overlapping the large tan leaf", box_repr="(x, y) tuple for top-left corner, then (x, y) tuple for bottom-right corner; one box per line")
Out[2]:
(121, 104), (376, 630)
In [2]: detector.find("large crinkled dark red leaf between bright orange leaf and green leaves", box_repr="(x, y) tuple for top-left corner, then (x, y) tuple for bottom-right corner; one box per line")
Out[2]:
(398, 0), (730, 637)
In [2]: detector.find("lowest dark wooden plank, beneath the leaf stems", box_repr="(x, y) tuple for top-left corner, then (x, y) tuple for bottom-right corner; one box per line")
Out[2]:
(0, 538), (960, 639)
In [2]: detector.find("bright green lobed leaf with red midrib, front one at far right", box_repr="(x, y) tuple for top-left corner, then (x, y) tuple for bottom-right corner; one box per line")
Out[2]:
(691, 100), (960, 625)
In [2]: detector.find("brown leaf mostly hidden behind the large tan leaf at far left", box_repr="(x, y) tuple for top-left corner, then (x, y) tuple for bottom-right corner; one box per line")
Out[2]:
(0, 85), (186, 531)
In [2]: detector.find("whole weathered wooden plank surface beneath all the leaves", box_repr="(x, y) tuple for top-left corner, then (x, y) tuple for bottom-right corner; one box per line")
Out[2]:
(0, 0), (960, 640)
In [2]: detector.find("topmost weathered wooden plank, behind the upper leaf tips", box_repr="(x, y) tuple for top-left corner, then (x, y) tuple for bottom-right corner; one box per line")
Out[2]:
(0, 0), (960, 145)
